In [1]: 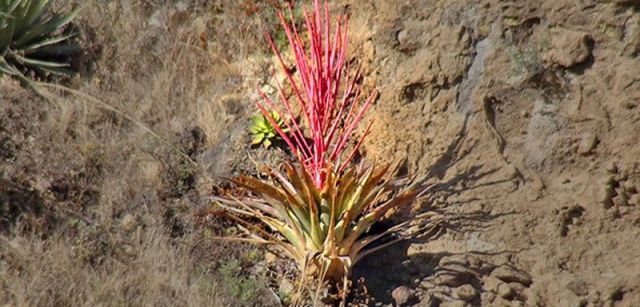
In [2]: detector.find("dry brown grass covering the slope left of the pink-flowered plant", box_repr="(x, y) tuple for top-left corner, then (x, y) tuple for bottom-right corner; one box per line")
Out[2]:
(0, 0), (284, 306)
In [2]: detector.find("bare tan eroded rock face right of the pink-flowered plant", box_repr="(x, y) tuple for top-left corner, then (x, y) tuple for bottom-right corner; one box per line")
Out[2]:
(342, 0), (640, 306)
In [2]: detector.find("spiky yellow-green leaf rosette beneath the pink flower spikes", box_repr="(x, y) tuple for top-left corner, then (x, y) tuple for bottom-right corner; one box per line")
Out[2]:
(215, 164), (420, 281)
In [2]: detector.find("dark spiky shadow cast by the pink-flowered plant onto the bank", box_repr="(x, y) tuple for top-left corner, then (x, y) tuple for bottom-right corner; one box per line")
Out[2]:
(353, 118), (515, 305)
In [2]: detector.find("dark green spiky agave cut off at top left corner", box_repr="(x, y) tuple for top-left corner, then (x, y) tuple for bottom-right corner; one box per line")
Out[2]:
(0, 0), (79, 78)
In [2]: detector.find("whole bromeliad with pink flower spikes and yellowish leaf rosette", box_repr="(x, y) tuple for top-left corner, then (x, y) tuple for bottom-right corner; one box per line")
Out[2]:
(216, 0), (421, 296)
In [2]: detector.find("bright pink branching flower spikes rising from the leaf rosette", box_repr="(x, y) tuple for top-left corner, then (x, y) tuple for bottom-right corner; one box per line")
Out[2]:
(256, 0), (377, 188)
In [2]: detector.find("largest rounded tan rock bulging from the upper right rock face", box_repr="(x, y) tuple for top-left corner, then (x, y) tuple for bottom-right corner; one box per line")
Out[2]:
(548, 28), (592, 68)
